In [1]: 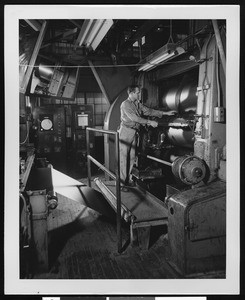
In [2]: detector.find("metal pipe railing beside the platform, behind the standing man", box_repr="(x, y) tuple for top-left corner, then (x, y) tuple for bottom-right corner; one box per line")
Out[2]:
(86, 127), (122, 253)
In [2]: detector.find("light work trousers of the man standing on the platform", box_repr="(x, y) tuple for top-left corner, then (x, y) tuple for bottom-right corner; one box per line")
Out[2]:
(119, 125), (136, 183)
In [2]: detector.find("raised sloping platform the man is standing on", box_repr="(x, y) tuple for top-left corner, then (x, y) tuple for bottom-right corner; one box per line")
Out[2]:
(94, 178), (168, 248)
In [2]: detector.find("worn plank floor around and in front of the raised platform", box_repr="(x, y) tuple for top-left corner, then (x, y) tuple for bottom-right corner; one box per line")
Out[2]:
(34, 183), (179, 279)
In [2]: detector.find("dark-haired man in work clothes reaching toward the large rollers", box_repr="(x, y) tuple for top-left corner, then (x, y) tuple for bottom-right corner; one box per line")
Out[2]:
(119, 85), (174, 186)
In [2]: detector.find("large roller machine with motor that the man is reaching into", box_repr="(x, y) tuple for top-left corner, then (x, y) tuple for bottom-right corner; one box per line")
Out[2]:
(105, 24), (226, 276)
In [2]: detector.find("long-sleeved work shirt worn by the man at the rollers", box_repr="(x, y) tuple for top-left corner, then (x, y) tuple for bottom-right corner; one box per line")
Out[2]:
(121, 99), (163, 129)
